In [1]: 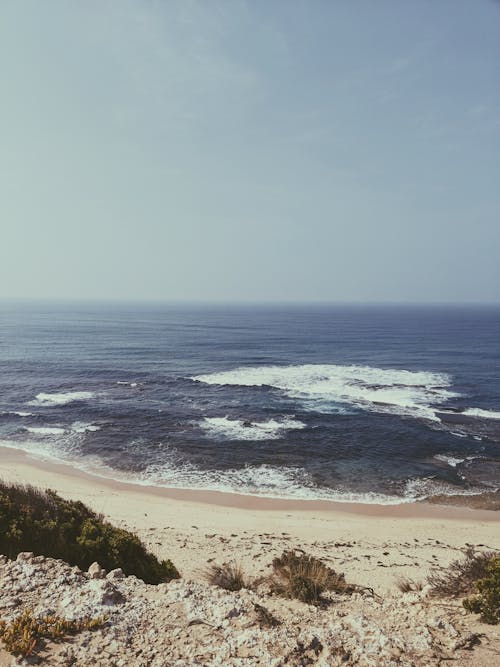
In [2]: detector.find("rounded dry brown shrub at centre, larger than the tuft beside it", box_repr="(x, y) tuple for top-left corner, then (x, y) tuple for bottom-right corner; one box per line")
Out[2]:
(271, 551), (358, 604)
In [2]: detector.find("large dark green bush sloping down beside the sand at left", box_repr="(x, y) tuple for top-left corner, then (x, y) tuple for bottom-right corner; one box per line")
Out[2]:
(0, 482), (179, 584)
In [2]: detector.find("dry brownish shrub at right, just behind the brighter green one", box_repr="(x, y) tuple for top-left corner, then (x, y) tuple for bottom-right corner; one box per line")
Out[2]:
(428, 547), (496, 597)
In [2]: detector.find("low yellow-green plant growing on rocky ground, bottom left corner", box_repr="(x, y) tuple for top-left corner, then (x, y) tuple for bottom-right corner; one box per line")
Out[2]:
(0, 609), (106, 657)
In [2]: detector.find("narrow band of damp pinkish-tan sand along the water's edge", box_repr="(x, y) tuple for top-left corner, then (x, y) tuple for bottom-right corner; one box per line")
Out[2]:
(0, 446), (500, 521)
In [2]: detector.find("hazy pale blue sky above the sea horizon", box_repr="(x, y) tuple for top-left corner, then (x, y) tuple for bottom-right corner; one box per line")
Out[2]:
(0, 0), (500, 303)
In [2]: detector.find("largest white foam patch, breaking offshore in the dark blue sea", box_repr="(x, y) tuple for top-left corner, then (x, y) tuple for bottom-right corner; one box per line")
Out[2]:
(192, 364), (458, 421)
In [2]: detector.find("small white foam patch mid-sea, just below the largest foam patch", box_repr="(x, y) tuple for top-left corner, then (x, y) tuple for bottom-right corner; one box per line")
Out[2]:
(200, 417), (306, 440)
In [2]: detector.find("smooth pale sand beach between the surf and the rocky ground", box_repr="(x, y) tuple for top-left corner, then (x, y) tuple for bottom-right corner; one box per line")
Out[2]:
(0, 448), (500, 591)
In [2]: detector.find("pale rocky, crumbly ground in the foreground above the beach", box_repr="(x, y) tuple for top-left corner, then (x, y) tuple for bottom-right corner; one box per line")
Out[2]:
(0, 554), (500, 667)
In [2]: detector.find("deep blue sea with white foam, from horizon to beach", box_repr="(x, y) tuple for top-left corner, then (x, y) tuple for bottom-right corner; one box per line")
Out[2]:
(0, 302), (500, 503)
